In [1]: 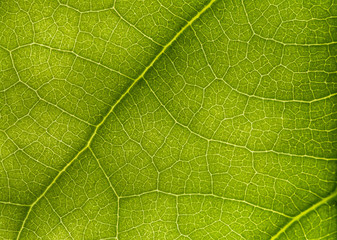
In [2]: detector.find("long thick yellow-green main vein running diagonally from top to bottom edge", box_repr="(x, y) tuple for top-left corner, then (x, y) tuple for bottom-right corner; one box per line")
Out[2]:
(17, 0), (216, 239)
